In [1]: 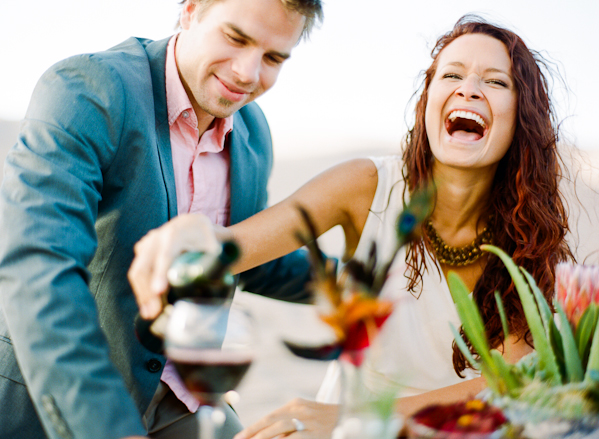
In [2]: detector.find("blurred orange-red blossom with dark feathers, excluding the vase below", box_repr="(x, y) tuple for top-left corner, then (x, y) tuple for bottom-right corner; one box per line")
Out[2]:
(285, 185), (433, 366)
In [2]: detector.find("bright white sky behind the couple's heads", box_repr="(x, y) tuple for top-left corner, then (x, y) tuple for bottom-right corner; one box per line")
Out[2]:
(0, 0), (599, 158)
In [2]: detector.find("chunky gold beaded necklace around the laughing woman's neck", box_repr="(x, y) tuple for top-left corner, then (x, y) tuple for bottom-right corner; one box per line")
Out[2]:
(424, 219), (493, 267)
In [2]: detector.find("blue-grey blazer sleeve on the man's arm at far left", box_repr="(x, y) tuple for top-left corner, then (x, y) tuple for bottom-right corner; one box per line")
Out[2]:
(0, 55), (145, 439)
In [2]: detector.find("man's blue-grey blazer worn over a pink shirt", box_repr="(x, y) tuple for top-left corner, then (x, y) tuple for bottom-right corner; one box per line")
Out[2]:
(0, 38), (309, 439)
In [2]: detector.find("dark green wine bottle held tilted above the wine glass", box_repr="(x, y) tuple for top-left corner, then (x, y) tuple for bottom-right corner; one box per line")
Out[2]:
(134, 241), (240, 354)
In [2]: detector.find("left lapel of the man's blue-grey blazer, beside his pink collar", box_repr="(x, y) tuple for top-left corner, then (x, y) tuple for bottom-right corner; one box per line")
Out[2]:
(142, 38), (177, 219)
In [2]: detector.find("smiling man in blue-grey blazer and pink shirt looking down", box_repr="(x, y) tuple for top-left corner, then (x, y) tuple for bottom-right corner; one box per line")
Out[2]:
(0, 0), (322, 439)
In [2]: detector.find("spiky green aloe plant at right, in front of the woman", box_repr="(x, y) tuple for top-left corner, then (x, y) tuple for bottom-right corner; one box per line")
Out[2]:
(447, 245), (599, 418)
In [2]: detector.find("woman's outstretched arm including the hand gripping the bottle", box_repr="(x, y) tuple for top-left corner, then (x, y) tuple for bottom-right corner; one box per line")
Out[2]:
(128, 159), (378, 318)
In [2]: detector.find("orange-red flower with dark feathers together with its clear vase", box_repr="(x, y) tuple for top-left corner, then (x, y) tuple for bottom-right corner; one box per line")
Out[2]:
(284, 185), (433, 439)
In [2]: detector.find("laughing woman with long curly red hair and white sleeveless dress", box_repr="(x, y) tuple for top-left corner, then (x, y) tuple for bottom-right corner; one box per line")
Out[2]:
(130, 16), (572, 439)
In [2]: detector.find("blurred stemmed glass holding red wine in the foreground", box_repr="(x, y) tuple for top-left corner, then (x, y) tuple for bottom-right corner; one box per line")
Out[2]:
(165, 300), (255, 439)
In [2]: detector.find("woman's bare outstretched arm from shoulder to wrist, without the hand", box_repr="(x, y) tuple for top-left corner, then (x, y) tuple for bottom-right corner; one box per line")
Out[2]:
(228, 159), (378, 273)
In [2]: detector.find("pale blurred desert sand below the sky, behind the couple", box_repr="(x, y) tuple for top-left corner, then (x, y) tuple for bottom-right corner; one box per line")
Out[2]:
(0, 121), (599, 425)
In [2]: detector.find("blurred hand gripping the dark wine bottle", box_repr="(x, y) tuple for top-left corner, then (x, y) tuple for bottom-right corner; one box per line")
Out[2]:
(127, 213), (219, 319)
